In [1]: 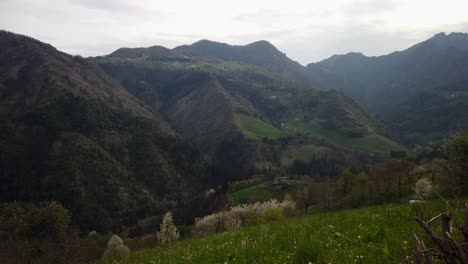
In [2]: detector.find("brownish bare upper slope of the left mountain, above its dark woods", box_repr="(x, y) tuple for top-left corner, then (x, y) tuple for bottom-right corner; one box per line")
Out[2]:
(0, 31), (158, 118)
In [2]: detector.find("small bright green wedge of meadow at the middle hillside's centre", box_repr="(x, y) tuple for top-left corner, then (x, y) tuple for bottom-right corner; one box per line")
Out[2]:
(236, 114), (283, 139)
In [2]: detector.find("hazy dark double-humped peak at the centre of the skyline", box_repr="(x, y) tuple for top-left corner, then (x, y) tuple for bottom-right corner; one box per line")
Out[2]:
(174, 40), (314, 88)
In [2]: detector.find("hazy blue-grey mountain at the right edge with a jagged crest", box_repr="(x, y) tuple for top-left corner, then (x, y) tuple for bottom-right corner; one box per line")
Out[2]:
(307, 33), (468, 144)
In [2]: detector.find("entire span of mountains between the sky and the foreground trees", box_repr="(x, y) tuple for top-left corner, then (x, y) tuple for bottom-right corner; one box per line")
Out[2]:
(0, 28), (468, 230)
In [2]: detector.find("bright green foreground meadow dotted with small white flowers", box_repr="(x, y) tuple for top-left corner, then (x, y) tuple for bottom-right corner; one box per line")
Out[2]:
(102, 202), (458, 264)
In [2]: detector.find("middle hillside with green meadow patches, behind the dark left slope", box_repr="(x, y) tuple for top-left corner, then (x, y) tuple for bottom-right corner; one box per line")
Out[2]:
(92, 44), (404, 171)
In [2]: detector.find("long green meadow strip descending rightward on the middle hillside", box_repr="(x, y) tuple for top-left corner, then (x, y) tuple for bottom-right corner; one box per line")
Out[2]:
(286, 121), (411, 154)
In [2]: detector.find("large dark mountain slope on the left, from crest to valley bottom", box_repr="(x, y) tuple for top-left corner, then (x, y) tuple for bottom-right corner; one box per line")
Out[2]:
(0, 31), (203, 230)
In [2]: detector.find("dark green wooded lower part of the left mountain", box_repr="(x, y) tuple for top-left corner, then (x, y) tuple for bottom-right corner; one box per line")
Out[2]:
(0, 94), (210, 232)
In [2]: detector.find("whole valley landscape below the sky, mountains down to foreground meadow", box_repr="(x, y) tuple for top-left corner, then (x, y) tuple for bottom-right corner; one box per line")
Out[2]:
(0, 28), (468, 263)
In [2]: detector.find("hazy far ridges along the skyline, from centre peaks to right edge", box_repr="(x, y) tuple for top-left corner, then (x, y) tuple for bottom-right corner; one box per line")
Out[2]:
(111, 33), (468, 146)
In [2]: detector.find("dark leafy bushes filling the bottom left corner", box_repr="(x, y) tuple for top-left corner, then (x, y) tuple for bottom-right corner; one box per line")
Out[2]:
(0, 201), (103, 264)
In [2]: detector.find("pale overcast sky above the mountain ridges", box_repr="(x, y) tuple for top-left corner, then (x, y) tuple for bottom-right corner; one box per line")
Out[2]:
(0, 0), (468, 64)
